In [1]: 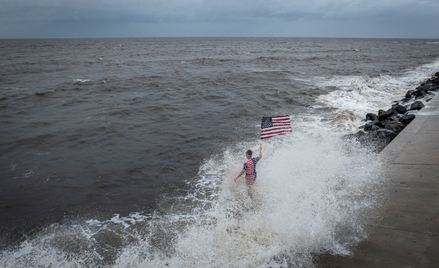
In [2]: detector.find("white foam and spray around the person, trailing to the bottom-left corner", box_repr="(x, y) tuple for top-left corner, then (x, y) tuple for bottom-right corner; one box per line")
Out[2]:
(0, 120), (385, 267)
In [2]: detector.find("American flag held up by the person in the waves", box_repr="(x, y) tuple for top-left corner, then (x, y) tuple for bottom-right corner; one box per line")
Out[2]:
(261, 115), (293, 140)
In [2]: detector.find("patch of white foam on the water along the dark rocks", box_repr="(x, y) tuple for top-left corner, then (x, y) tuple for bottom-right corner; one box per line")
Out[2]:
(316, 60), (439, 132)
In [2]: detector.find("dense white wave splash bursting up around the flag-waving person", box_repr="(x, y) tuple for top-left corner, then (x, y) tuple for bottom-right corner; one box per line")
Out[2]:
(116, 126), (384, 267)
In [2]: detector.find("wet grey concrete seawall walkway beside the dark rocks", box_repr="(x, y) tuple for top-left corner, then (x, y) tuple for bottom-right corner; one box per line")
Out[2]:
(321, 94), (439, 267)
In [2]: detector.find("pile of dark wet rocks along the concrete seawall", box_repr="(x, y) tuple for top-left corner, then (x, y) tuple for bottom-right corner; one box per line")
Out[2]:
(347, 72), (439, 152)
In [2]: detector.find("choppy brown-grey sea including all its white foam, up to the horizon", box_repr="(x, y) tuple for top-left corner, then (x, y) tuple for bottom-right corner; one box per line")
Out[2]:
(0, 38), (439, 267)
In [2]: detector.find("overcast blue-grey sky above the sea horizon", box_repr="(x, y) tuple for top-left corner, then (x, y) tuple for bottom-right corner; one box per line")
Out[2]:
(0, 0), (439, 38)
